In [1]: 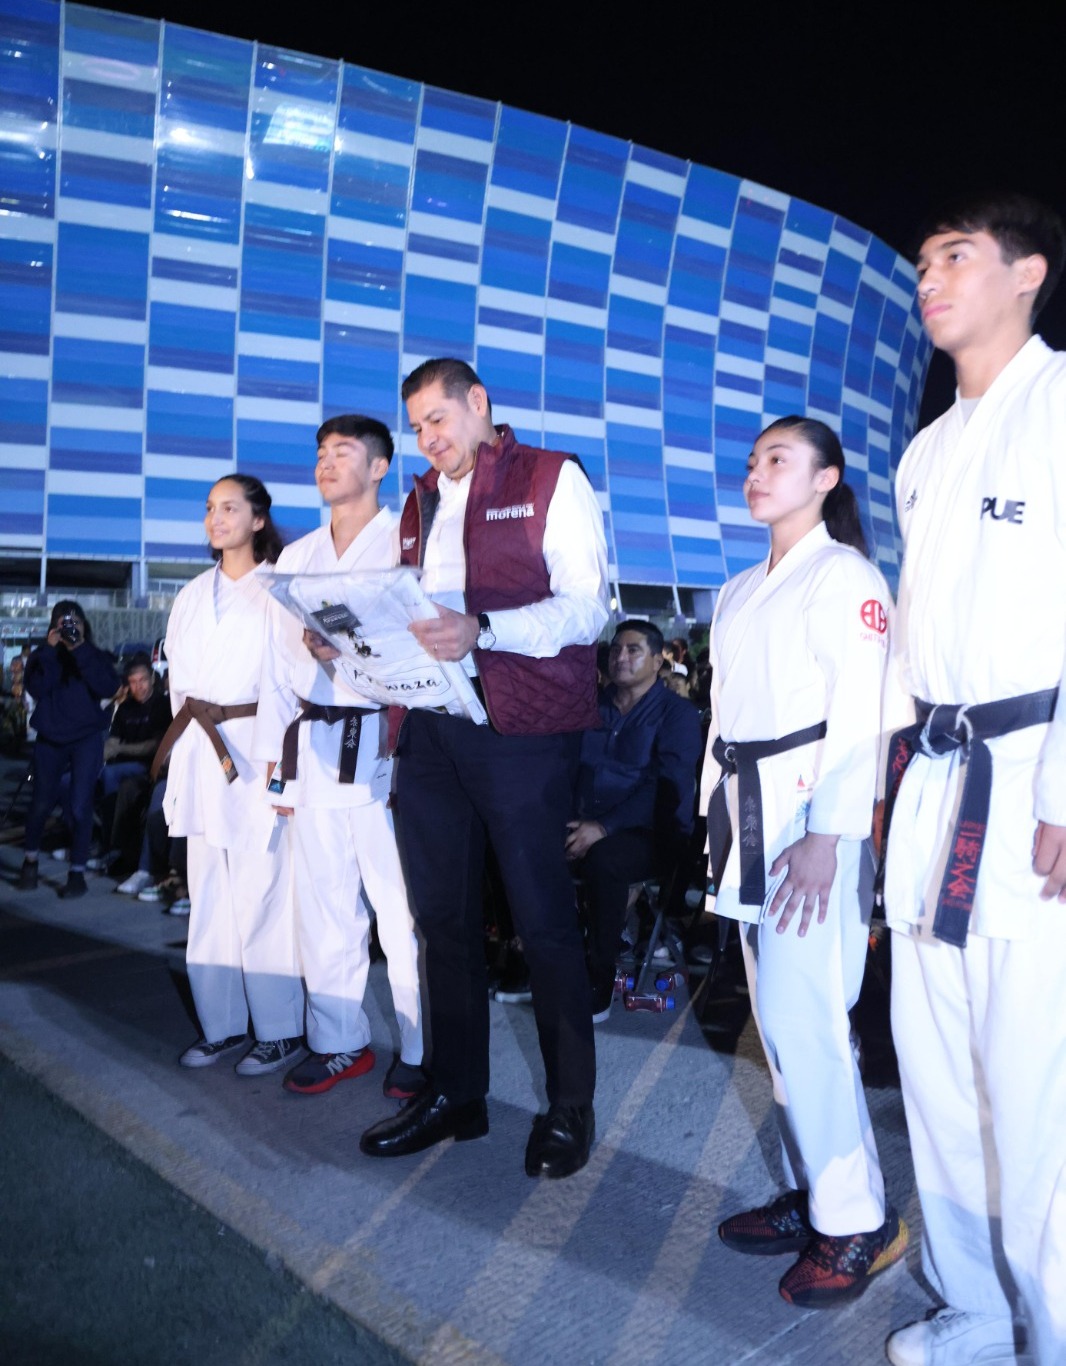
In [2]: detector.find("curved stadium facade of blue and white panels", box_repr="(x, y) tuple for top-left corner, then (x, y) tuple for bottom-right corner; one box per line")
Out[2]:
(0, 0), (929, 589)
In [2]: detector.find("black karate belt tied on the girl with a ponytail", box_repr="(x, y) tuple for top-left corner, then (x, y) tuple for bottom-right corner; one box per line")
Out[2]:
(707, 721), (825, 906)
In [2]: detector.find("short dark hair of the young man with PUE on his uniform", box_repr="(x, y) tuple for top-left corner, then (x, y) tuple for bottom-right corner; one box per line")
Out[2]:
(914, 191), (1066, 317)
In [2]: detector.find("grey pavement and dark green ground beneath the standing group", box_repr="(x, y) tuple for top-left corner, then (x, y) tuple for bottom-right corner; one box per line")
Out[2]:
(0, 754), (931, 1366)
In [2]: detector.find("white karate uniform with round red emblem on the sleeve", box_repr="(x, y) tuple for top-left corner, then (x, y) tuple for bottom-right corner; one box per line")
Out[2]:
(701, 523), (891, 1236)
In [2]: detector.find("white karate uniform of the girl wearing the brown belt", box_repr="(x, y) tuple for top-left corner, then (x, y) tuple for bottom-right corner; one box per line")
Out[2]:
(163, 566), (303, 1042)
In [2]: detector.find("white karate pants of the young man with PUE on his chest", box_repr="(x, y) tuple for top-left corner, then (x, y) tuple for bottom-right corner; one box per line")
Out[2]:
(892, 923), (1066, 1366)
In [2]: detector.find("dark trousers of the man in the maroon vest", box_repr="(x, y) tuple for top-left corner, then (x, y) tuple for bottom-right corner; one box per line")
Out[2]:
(396, 710), (596, 1105)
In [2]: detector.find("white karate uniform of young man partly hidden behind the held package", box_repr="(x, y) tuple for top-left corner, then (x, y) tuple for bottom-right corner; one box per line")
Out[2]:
(254, 508), (422, 1064)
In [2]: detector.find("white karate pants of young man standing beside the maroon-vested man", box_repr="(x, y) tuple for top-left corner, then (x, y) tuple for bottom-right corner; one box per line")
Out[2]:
(292, 802), (422, 1064)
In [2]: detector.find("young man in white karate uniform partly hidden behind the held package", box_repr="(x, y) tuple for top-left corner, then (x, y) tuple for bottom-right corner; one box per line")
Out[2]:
(254, 415), (425, 1100)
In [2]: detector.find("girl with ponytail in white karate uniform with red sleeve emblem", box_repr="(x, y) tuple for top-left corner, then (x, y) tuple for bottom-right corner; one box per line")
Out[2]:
(701, 417), (907, 1306)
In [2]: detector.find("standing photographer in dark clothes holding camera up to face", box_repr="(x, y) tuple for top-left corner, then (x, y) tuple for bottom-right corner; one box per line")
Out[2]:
(16, 598), (122, 896)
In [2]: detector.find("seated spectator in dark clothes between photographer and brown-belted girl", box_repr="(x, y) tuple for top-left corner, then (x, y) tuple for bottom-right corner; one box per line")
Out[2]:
(97, 653), (171, 870)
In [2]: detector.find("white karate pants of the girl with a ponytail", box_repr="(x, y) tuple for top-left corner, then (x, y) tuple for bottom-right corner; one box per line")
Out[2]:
(741, 840), (884, 1238)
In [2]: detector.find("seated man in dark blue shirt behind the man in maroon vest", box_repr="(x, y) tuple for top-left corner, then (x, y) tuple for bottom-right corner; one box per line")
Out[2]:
(566, 622), (702, 1022)
